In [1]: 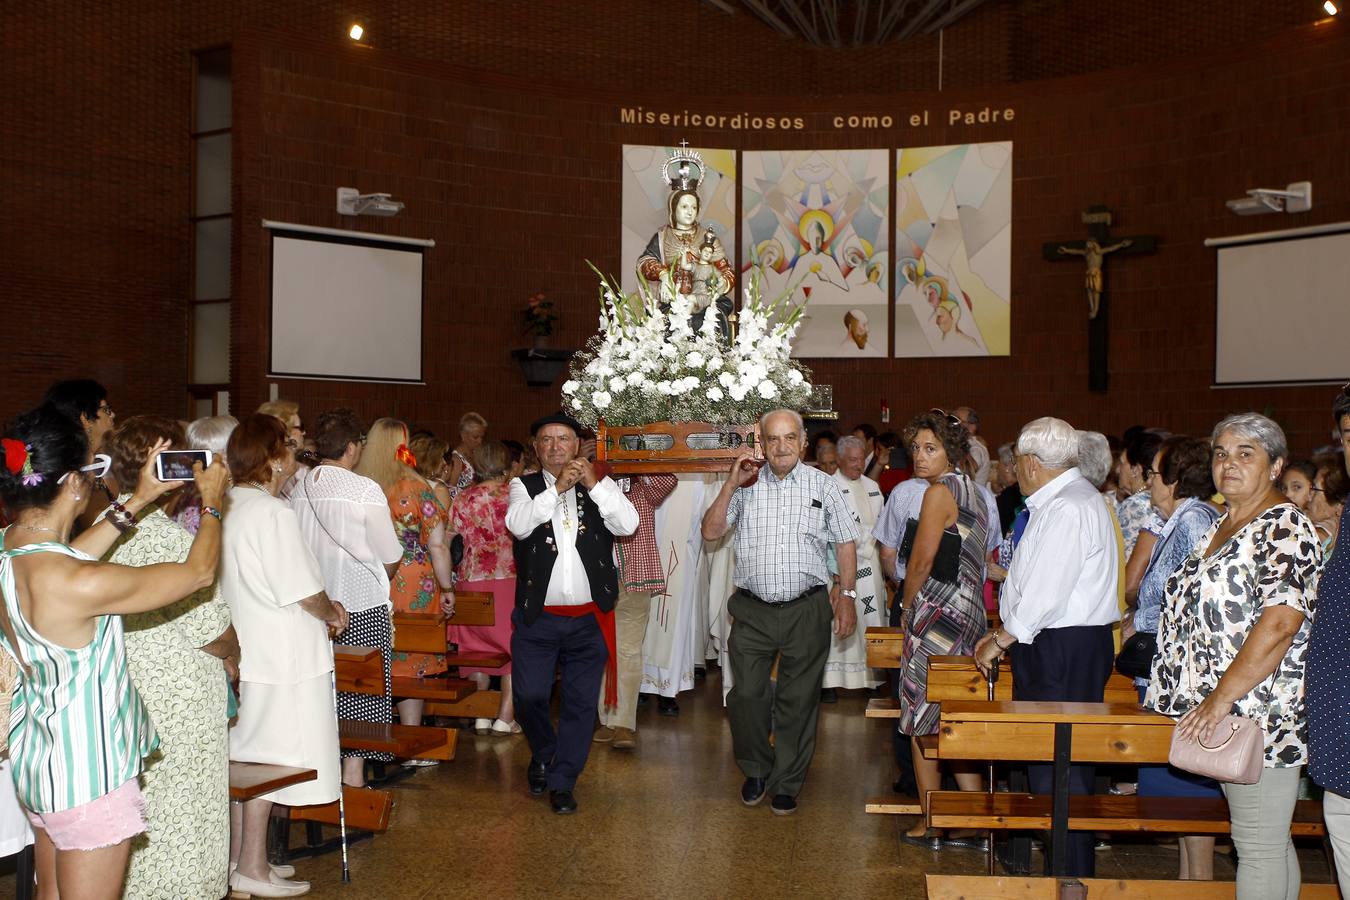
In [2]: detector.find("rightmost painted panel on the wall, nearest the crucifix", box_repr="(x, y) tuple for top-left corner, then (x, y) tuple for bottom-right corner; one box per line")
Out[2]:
(895, 140), (1013, 358)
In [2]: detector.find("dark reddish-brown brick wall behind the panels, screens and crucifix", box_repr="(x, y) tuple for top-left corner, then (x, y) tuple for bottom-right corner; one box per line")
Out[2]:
(0, 0), (1350, 447)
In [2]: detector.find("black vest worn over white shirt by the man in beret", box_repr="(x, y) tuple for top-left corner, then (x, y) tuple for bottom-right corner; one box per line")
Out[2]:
(513, 472), (618, 625)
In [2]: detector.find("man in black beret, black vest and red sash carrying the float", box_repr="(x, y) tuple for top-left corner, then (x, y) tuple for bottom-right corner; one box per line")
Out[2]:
(506, 413), (637, 815)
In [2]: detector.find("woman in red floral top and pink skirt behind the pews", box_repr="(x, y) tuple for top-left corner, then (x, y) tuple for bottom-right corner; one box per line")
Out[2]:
(447, 441), (520, 734)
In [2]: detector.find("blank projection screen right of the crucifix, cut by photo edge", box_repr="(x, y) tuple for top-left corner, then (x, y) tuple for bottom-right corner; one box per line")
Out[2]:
(1214, 224), (1350, 385)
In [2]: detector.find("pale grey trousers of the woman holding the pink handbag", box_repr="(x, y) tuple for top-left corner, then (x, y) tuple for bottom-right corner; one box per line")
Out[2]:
(1223, 765), (1303, 900)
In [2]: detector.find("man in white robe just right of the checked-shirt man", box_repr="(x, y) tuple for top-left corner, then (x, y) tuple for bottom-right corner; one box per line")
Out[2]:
(821, 434), (886, 699)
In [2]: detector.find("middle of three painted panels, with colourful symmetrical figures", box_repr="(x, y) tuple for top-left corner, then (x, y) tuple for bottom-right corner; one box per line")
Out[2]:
(741, 150), (890, 359)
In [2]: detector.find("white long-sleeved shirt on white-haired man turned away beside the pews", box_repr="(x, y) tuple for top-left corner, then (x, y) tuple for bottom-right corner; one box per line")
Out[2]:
(999, 468), (1121, 644)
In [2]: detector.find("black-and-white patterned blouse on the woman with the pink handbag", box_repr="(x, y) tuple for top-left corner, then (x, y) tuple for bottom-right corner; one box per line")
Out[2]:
(1143, 503), (1322, 769)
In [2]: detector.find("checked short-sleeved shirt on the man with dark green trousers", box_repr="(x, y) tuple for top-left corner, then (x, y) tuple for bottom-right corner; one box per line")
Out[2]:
(726, 463), (857, 603)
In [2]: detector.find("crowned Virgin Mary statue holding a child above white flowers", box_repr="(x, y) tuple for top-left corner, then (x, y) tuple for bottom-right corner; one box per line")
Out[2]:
(637, 150), (736, 340)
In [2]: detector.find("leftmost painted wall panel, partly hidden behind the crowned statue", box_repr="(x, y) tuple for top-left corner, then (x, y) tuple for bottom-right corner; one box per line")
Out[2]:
(621, 144), (736, 293)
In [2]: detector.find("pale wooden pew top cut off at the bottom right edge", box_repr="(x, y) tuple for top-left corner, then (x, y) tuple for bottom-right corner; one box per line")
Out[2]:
(925, 874), (1341, 900)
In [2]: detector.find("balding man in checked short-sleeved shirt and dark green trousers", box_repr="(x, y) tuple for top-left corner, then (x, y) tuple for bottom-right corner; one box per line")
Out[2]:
(702, 409), (857, 815)
